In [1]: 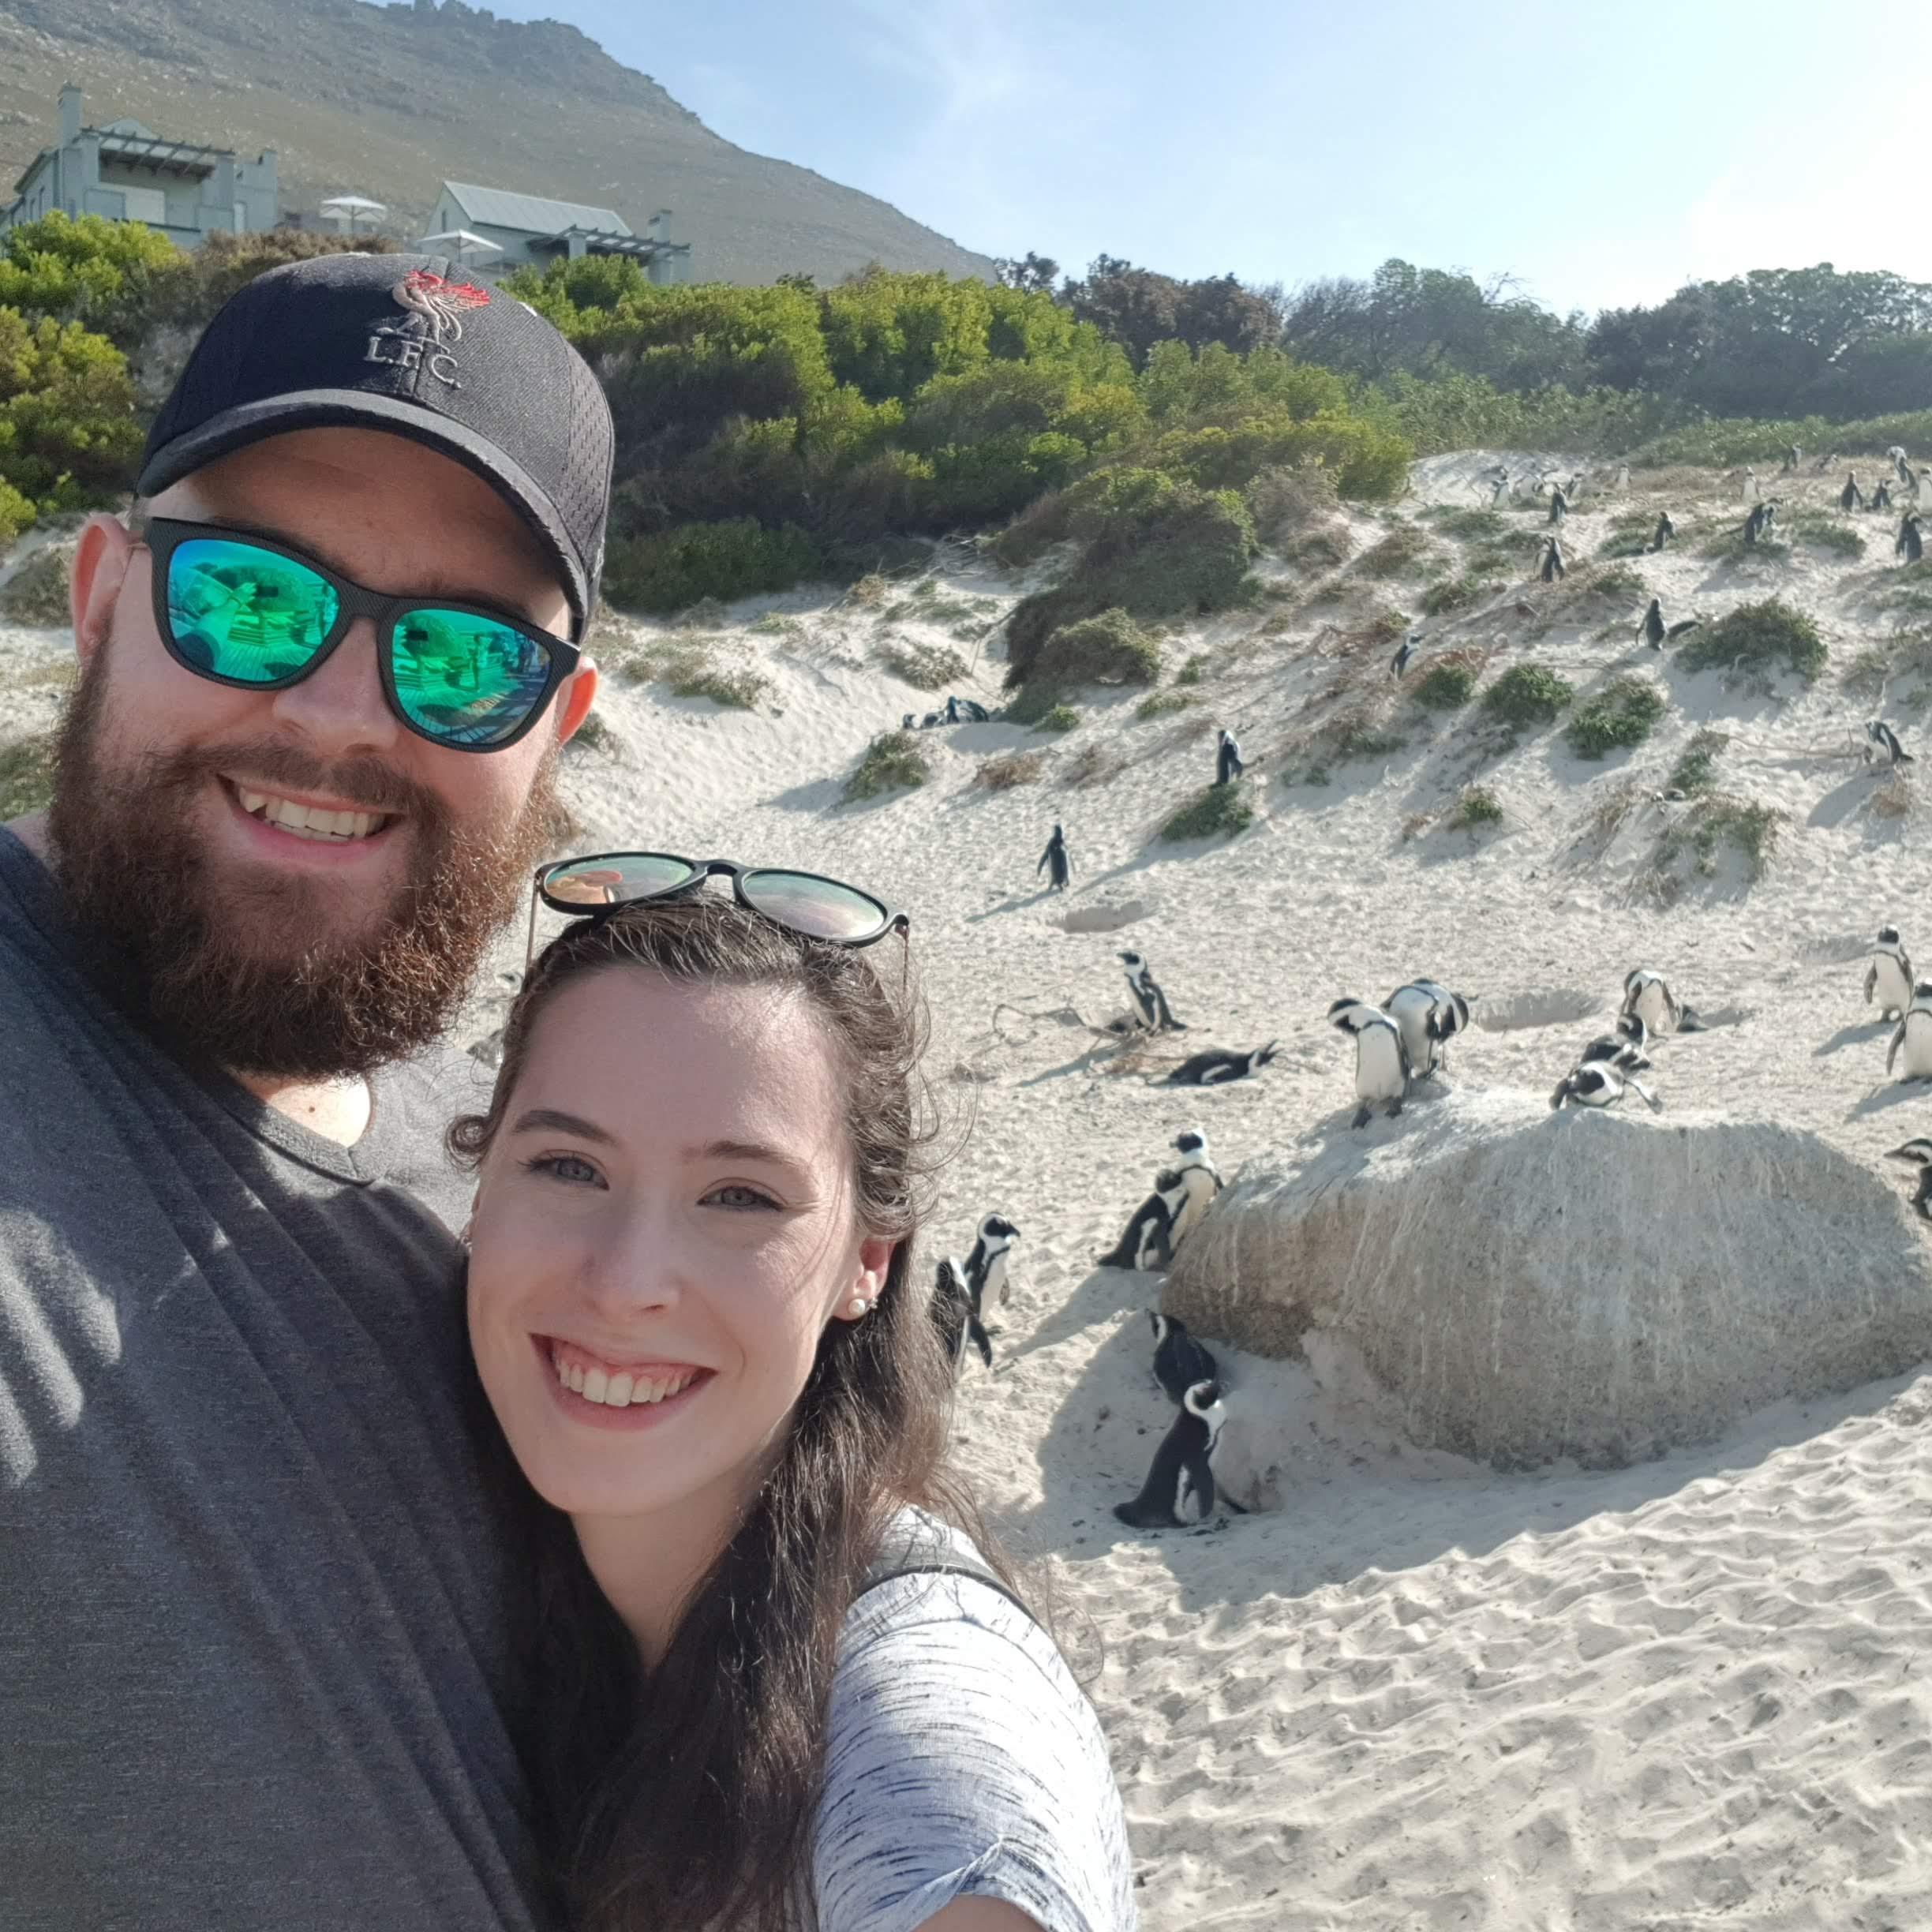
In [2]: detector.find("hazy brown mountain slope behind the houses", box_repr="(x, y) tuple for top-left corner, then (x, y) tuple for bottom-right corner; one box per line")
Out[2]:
(0, 0), (991, 282)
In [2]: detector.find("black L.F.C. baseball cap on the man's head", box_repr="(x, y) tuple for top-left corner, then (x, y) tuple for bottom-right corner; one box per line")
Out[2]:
(135, 255), (612, 638)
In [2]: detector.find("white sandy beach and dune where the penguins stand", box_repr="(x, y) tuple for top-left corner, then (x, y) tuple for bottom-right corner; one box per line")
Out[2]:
(0, 452), (1932, 1932)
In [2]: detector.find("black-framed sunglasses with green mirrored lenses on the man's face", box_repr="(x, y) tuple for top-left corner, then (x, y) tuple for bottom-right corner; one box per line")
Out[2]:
(145, 516), (582, 751)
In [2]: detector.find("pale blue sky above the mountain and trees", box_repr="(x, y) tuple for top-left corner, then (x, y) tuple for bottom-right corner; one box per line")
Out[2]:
(479, 0), (1932, 309)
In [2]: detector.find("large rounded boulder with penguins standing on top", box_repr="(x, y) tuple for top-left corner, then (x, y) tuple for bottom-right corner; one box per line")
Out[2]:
(1163, 1090), (1932, 1468)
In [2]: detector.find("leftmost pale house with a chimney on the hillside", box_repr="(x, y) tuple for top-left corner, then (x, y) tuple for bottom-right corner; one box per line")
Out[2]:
(0, 83), (279, 247)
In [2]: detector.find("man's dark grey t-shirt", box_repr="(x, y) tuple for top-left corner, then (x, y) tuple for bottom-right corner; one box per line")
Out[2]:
(0, 831), (543, 1932)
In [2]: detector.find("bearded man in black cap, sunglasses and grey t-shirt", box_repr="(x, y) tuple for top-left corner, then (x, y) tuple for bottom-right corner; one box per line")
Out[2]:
(0, 255), (611, 1932)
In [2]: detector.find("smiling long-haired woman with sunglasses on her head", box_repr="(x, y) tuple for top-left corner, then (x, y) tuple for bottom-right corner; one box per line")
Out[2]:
(452, 854), (1134, 1932)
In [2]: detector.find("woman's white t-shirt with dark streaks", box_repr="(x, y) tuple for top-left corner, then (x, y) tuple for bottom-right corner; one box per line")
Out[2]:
(811, 1518), (1136, 1932)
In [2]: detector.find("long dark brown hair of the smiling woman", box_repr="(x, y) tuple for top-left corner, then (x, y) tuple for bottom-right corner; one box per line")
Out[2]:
(450, 894), (1014, 1932)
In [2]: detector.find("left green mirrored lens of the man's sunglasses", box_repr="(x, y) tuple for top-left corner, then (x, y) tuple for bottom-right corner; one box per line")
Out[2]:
(168, 537), (338, 684)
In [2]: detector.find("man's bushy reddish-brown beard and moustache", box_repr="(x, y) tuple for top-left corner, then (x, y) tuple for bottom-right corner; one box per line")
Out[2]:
(48, 639), (568, 1080)
